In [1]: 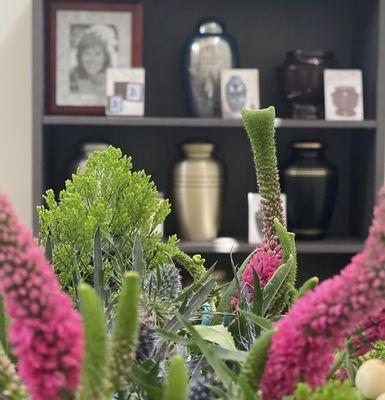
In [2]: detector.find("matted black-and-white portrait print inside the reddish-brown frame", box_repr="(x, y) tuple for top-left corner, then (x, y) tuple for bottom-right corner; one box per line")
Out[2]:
(54, 6), (135, 112)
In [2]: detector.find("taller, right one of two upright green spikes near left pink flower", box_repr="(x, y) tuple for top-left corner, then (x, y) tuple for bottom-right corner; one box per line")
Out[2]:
(110, 271), (140, 391)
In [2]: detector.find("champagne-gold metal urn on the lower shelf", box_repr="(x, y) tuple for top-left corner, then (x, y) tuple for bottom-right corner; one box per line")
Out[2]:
(173, 142), (223, 241)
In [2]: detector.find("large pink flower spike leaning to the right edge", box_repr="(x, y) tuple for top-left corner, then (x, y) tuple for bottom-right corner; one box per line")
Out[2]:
(261, 191), (385, 400)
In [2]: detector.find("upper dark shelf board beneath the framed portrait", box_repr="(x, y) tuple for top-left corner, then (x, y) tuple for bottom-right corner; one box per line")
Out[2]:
(43, 115), (377, 129)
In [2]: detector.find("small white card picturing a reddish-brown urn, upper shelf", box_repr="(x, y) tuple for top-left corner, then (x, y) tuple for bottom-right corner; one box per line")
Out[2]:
(324, 69), (364, 121)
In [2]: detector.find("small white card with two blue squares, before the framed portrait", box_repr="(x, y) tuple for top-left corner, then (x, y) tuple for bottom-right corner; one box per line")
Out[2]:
(106, 68), (145, 116)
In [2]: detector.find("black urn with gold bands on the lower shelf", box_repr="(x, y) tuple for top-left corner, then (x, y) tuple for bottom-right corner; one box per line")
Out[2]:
(281, 141), (338, 239)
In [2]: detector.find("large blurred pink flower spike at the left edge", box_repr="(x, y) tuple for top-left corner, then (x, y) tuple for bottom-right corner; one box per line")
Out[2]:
(0, 194), (83, 400)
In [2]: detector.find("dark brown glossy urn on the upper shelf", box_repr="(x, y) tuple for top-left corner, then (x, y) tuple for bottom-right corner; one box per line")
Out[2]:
(278, 50), (337, 119)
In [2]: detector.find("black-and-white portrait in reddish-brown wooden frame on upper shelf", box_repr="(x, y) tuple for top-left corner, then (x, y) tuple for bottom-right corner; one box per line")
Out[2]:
(46, 1), (143, 115)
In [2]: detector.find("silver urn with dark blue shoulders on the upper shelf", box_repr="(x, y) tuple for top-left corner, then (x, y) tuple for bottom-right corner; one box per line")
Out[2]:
(182, 18), (237, 118)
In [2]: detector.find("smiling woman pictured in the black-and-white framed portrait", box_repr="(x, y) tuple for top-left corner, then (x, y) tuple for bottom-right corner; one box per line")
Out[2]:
(70, 25), (118, 98)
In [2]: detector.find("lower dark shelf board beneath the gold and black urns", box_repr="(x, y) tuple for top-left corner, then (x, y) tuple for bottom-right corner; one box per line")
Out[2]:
(179, 237), (364, 254)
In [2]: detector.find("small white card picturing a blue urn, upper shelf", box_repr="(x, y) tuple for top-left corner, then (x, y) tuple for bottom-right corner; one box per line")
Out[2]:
(221, 69), (259, 119)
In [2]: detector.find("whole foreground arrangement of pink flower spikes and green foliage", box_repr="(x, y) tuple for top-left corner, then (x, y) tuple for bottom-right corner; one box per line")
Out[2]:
(0, 107), (385, 400)
